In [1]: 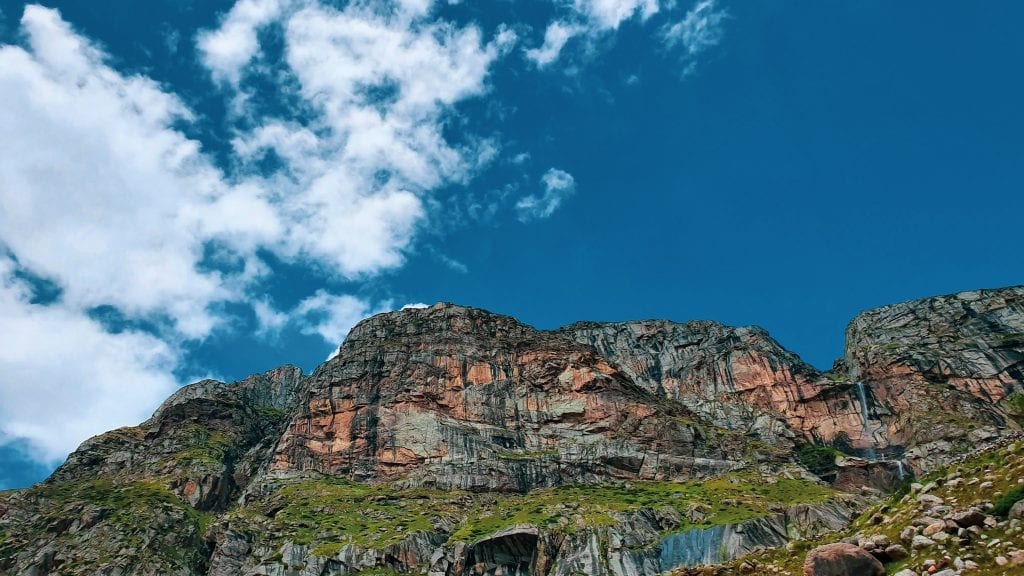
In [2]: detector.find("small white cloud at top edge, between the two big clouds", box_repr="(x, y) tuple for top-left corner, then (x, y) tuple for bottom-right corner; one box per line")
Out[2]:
(197, 0), (287, 85)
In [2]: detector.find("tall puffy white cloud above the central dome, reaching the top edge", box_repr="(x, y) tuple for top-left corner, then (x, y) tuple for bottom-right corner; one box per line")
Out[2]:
(224, 1), (516, 279)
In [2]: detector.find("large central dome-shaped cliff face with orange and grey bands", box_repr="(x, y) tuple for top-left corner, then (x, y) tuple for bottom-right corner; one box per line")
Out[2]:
(273, 304), (746, 491)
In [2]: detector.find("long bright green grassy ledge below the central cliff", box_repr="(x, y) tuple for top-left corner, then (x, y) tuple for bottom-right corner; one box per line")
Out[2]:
(230, 475), (834, 557)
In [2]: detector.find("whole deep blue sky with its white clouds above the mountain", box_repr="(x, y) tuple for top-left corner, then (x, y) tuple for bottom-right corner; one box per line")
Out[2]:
(0, 0), (1024, 488)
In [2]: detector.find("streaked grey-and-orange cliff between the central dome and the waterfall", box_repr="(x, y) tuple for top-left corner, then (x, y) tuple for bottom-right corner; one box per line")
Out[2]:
(561, 321), (886, 450)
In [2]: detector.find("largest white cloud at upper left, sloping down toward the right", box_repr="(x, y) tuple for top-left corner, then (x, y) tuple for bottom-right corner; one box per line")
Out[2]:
(0, 6), (280, 338)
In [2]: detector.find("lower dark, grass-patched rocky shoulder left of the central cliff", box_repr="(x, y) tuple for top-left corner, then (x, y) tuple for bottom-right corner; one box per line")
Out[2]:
(0, 366), (303, 576)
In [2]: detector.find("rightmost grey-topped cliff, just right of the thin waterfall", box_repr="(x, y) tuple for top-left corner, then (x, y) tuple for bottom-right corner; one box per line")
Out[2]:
(844, 287), (1024, 455)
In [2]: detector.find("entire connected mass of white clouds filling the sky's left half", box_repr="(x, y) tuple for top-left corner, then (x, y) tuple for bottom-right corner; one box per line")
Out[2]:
(0, 0), (507, 467)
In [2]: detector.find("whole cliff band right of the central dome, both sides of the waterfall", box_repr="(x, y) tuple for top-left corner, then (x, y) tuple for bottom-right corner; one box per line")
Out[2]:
(561, 287), (1024, 454)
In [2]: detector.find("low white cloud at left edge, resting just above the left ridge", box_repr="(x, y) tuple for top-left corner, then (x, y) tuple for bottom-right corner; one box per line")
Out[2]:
(0, 256), (178, 463)
